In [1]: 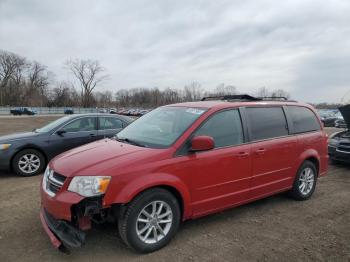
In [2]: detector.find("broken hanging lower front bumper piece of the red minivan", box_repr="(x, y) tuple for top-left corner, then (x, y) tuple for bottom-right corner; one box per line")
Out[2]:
(40, 208), (85, 251)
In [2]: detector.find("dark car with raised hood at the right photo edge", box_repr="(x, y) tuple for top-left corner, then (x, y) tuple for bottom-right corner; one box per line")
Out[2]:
(328, 104), (350, 163)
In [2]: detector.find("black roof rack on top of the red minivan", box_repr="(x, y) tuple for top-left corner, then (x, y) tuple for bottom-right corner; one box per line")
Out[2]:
(201, 94), (295, 102)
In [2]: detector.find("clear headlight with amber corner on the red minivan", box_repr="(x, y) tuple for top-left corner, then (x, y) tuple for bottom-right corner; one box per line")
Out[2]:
(68, 176), (111, 197)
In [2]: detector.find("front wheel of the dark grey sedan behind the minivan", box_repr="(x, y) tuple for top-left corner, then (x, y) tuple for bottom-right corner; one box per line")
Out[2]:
(12, 149), (45, 177)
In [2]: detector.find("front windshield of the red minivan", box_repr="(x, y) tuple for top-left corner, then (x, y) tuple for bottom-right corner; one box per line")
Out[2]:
(117, 107), (206, 148)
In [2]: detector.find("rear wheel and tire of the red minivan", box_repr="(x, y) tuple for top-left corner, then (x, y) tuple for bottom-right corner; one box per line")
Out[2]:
(289, 160), (317, 201)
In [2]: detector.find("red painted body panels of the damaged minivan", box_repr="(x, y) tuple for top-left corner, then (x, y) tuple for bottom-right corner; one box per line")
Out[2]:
(41, 101), (328, 226)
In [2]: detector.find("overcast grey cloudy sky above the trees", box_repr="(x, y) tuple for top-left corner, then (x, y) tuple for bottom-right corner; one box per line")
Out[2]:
(0, 0), (350, 102)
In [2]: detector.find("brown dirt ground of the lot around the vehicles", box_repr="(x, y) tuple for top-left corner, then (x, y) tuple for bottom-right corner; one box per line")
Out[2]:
(0, 116), (350, 261)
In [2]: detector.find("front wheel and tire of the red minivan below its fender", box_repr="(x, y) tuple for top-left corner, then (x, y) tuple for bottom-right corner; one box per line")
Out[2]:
(118, 188), (181, 253)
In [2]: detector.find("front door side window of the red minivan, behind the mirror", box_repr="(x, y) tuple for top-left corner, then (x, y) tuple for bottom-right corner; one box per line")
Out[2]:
(195, 109), (243, 148)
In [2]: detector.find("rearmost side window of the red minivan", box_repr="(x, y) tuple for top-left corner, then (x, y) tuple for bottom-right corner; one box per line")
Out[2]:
(288, 106), (321, 134)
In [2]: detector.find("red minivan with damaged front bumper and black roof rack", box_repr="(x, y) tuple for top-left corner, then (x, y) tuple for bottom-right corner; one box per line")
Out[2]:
(40, 95), (328, 253)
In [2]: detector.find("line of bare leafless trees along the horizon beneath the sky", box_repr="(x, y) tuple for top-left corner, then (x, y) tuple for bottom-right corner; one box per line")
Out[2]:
(0, 50), (290, 108)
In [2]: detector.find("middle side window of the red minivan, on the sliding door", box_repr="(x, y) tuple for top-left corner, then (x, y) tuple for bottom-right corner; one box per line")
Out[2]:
(246, 107), (288, 141)
